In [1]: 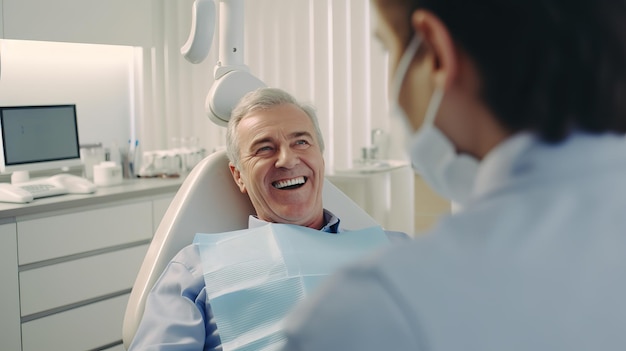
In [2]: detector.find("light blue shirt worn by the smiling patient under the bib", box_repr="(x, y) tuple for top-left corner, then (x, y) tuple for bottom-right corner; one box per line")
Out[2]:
(129, 210), (408, 351)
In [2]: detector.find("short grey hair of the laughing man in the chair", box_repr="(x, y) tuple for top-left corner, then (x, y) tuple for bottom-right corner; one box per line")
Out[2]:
(226, 88), (324, 169)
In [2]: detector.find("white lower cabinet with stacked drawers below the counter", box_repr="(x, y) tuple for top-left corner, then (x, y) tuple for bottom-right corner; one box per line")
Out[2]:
(0, 192), (174, 351)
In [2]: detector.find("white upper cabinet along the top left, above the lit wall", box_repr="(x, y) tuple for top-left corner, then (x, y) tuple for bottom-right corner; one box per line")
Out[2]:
(0, 0), (152, 47)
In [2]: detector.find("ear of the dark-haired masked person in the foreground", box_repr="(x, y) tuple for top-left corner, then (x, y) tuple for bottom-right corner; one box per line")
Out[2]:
(411, 10), (459, 89)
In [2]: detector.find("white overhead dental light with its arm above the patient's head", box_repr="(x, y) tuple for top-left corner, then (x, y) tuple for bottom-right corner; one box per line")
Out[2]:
(180, 0), (266, 126)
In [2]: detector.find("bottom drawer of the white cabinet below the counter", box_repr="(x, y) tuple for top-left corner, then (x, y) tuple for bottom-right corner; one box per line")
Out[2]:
(22, 295), (128, 351)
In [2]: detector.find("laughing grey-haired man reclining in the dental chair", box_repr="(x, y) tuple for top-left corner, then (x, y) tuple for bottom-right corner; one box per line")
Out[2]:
(130, 88), (407, 350)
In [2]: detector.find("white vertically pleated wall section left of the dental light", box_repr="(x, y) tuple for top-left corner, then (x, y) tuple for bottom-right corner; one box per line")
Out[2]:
(137, 0), (225, 152)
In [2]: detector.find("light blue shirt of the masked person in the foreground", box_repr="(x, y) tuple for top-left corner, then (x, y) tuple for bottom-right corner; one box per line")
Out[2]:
(286, 133), (626, 351)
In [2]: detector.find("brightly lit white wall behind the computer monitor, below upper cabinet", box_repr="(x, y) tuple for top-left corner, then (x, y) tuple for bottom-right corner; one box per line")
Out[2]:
(0, 40), (134, 152)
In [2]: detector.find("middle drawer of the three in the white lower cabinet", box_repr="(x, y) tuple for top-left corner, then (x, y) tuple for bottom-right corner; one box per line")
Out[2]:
(20, 245), (148, 316)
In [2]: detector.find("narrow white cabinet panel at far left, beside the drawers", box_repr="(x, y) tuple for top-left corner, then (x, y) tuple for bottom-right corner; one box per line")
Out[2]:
(0, 223), (22, 350)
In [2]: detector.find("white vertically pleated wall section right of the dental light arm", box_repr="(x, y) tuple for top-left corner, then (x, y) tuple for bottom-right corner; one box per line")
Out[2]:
(246, 0), (390, 170)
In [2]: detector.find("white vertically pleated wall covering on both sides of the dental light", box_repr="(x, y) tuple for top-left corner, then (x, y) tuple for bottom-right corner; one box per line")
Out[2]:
(148, 0), (404, 172)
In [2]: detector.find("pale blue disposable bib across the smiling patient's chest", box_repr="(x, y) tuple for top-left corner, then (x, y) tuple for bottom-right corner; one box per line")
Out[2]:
(194, 223), (389, 351)
